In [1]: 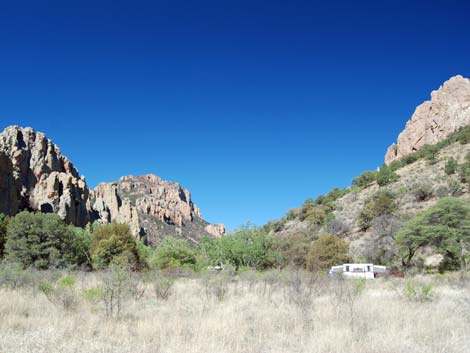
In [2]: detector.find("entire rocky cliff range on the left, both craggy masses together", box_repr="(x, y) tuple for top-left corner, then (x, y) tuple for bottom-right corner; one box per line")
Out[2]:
(0, 126), (225, 244)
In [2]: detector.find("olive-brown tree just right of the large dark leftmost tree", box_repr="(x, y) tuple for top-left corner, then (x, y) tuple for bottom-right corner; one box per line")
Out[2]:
(90, 223), (142, 269)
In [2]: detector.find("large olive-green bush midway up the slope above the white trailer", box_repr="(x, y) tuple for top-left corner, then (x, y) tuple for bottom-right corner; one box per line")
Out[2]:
(359, 191), (397, 230)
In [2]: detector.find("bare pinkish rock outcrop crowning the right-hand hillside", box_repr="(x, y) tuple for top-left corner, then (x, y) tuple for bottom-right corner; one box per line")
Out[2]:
(385, 75), (470, 164)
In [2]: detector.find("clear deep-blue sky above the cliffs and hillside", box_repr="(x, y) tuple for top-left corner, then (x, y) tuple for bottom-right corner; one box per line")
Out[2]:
(0, 0), (470, 229)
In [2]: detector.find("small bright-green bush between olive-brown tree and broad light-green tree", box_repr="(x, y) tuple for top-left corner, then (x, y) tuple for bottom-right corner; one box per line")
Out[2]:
(151, 237), (197, 269)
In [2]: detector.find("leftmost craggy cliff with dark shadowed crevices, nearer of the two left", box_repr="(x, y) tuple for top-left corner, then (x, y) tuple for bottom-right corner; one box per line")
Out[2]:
(0, 126), (90, 226)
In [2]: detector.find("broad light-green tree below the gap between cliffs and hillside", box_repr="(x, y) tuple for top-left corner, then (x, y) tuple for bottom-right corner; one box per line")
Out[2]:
(200, 226), (282, 270)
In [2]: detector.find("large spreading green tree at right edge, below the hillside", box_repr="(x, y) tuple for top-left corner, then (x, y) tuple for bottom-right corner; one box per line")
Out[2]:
(396, 198), (470, 270)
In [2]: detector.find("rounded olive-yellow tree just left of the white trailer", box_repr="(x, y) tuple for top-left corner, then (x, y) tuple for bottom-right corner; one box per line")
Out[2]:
(307, 234), (349, 271)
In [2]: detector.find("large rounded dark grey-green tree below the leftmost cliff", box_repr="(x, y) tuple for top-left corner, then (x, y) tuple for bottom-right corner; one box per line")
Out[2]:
(5, 211), (77, 269)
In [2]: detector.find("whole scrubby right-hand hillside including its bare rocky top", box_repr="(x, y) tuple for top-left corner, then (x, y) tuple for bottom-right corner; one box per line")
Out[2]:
(265, 76), (470, 267)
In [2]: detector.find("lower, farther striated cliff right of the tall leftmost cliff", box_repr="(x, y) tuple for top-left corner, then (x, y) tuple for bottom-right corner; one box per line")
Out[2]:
(93, 174), (225, 244)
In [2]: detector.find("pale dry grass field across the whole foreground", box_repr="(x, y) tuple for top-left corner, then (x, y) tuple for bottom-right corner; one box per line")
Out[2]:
(0, 273), (470, 353)
